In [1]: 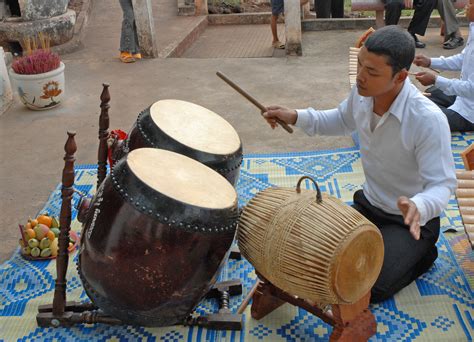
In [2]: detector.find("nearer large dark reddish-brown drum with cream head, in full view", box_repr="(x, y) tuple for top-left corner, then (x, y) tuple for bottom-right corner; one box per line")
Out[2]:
(79, 148), (238, 326)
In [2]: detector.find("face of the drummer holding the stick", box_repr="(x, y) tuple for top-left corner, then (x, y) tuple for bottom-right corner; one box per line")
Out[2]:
(357, 47), (399, 97)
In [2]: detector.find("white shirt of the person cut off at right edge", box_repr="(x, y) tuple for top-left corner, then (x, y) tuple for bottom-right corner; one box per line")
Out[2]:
(431, 23), (474, 123)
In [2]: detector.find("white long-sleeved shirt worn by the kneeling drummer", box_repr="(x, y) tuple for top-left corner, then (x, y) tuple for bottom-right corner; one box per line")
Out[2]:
(295, 79), (457, 226)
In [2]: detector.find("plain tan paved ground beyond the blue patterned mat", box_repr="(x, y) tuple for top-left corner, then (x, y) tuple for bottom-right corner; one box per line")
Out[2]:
(0, 0), (467, 262)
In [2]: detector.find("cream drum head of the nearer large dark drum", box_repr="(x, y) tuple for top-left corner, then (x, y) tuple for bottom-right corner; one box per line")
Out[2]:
(127, 148), (237, 209)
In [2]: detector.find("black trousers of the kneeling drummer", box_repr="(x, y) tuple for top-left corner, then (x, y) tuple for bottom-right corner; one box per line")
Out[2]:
(352, 190), (440, 303)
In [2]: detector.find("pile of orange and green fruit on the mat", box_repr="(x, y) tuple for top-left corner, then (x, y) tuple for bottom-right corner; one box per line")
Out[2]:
(20, 214), (75, 258)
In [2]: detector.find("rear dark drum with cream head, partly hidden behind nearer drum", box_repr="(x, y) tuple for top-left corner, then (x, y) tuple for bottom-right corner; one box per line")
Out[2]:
(114, 100), (242, 185)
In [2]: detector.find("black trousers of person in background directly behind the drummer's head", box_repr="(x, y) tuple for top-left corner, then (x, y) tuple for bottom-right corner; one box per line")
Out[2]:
(382, 0), (437, 36)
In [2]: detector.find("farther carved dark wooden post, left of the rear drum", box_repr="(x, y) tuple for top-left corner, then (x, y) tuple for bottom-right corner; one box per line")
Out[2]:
(97, 83), (110, 189)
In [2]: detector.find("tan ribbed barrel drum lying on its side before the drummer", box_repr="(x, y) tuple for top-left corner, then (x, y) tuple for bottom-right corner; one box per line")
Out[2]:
(237, 188), (384, 304)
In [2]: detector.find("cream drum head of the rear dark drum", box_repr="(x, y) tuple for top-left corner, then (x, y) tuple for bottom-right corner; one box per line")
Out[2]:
(150, 100), (240, 155)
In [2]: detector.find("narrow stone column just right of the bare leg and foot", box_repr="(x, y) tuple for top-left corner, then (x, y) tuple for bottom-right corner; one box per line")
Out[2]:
(285, 0), (302, 56)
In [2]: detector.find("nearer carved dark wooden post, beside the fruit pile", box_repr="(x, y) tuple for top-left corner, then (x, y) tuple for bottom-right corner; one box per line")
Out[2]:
(53, 132), (77, 316)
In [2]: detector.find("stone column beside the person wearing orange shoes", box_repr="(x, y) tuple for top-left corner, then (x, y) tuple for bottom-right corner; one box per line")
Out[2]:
(132, 0), (158, 58)
